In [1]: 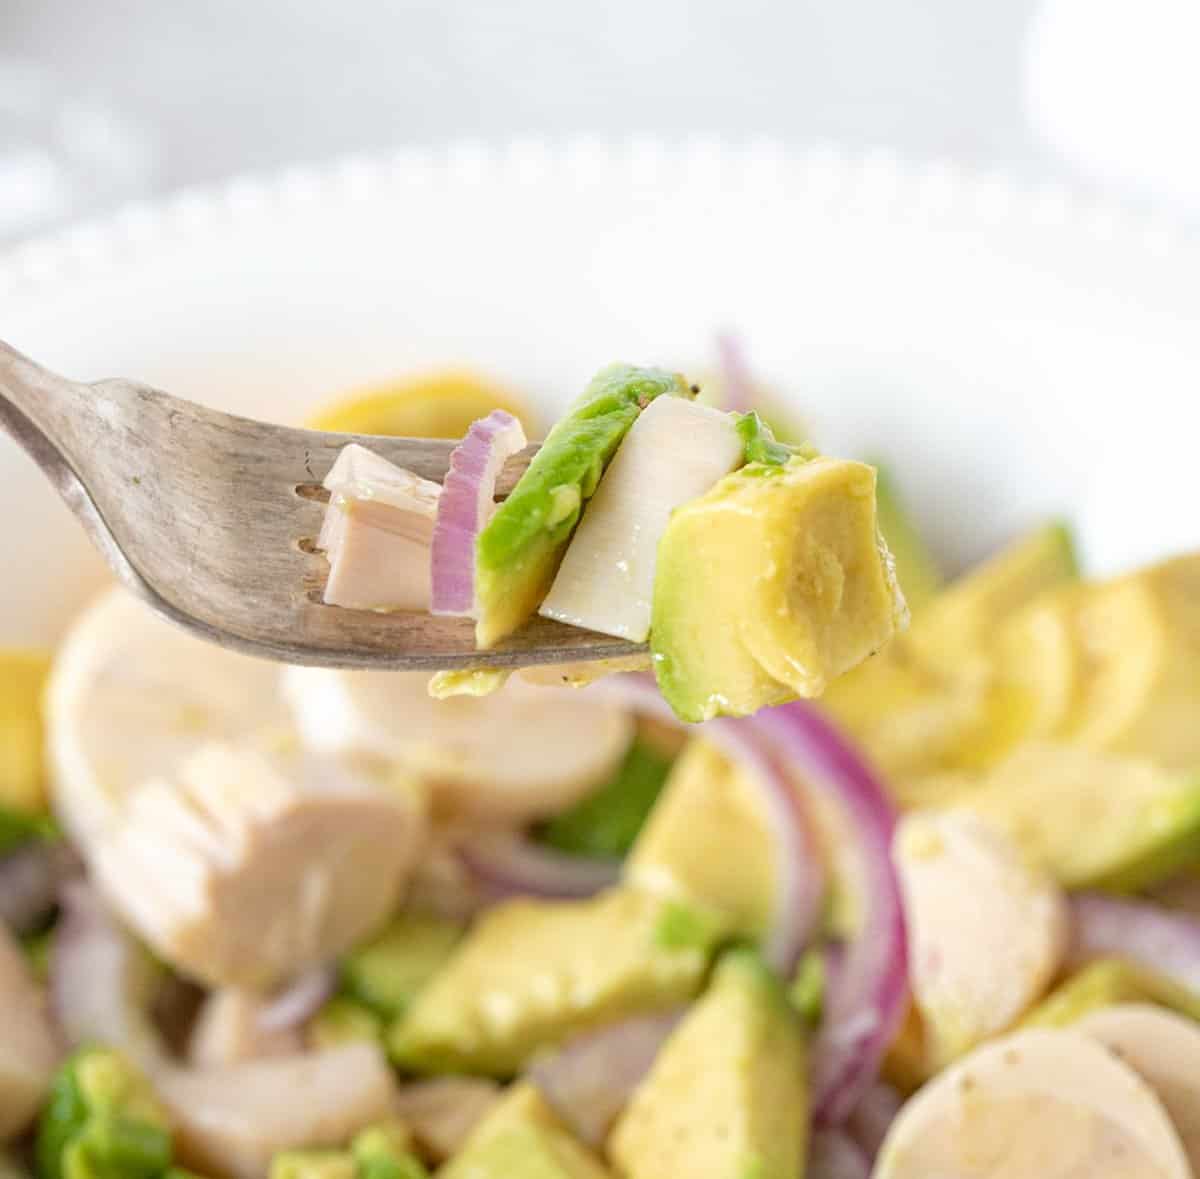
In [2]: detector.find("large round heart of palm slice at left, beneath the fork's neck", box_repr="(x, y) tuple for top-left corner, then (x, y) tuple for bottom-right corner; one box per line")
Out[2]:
(47, 590), (287, 851)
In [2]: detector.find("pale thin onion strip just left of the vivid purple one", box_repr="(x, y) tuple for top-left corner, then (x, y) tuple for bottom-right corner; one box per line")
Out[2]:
(584, 675), (824, 977)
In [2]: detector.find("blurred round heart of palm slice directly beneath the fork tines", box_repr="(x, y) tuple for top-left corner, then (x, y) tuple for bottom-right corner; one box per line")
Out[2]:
(284, 668), (632, 822)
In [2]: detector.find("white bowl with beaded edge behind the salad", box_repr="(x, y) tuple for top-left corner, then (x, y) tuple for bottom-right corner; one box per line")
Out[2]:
(0, 142), (1200, 642)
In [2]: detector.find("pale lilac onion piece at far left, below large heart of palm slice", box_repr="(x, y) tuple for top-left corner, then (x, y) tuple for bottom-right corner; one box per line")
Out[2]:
(49, 880), (164, 1064)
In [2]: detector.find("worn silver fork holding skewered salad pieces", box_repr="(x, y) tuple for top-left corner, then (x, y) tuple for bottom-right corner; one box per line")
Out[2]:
(0, 341), (644, 671)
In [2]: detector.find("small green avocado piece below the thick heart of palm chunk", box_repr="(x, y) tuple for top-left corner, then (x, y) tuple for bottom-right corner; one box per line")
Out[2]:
(341, 914), (463, 1019)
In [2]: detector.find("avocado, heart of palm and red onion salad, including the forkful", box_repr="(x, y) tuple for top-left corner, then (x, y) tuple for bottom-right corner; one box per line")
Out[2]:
(0, 360), (1200, 1179)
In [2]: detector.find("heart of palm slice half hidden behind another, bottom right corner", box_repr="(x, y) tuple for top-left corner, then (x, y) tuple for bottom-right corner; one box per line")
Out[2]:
(1074, 1003), (1200, 1172)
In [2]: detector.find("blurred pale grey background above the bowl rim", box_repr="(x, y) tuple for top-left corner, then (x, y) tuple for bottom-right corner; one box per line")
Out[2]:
(0, 0), (1132, 218)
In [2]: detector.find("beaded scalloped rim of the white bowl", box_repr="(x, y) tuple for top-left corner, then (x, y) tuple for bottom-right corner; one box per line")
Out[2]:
(0, 134), (1200, 299)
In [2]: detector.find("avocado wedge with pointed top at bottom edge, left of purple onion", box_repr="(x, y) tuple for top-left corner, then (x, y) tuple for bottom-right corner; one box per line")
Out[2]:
(608, 950), (809, 1179)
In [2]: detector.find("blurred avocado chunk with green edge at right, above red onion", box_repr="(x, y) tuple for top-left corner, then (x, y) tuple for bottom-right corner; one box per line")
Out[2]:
(958, 744), (1200, 892)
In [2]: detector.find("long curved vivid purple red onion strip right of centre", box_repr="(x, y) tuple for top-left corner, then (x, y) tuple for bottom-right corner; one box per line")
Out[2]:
(749, 702), (908, 1125)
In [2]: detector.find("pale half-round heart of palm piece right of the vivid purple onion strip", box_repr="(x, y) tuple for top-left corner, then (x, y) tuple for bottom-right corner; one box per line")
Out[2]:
(894, 810), (1067, 1063)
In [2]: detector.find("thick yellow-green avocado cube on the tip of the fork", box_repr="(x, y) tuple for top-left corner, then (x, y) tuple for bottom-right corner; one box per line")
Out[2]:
(650, 455), (905, 722)
